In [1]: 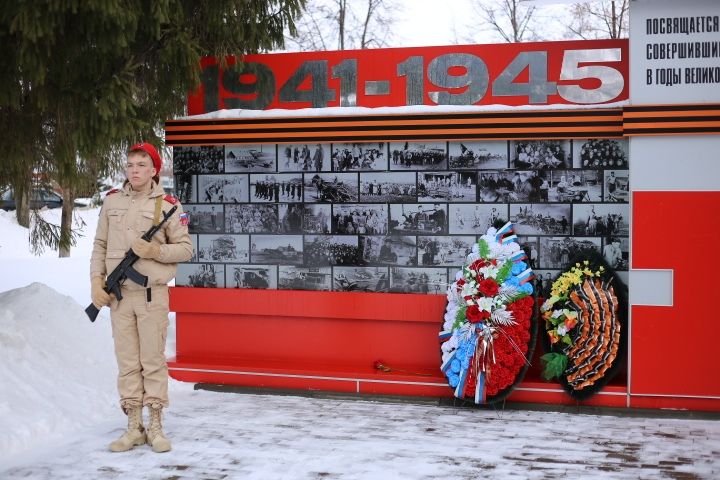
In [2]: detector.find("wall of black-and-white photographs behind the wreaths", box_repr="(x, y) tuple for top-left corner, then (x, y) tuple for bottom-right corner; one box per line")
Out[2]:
(173, 139), (630, 294)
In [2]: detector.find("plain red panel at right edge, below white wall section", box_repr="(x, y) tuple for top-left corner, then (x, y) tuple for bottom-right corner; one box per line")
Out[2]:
(630, 192), (720, 410)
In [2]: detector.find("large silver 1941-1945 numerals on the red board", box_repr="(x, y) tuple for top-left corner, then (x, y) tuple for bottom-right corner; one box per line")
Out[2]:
(202, 48), (625, 111)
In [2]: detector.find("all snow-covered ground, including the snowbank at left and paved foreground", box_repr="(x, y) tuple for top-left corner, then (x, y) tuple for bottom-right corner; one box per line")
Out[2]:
(0, 205), (720, 479)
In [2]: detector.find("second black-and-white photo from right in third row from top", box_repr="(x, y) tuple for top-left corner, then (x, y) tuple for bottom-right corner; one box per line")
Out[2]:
(510, 203), (572, 235)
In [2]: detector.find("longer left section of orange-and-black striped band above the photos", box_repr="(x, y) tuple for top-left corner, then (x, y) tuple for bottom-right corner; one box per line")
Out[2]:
(166, 109), (622, 145)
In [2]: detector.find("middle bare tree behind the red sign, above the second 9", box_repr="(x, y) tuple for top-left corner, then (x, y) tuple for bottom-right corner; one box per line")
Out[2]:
(471, 0), (538, 43)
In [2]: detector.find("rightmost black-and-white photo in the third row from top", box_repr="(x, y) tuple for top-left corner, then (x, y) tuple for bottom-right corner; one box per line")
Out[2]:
(573, 203), (632, 236)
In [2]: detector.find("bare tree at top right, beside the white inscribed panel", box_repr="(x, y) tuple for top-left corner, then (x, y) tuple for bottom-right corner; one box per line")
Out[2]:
(567, 0), (630, 40)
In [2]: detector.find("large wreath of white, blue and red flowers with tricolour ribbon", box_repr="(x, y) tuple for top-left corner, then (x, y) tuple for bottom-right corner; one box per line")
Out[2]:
(439, 222), (535, 404)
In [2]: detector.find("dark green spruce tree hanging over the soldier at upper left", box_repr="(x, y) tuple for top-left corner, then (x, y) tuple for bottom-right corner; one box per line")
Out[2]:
(0, 0), (305, 256)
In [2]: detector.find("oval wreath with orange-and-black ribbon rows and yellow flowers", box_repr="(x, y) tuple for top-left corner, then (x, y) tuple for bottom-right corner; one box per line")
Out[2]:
(540, 252), (627, 400)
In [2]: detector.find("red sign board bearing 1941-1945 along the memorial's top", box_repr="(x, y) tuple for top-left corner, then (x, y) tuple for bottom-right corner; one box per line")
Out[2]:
(188, 39), (629, 115)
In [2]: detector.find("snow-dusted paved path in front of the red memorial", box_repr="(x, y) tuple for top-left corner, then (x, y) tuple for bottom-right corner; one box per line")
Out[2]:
(0, 390), (720, 480)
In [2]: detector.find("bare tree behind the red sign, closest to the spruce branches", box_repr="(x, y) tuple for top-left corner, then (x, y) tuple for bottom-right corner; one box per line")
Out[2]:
(285, 0), (399, 51)
